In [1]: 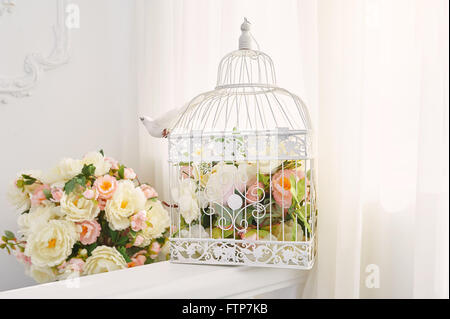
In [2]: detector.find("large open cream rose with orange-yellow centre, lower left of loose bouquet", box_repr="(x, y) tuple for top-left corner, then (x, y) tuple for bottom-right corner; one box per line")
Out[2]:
(25, 220), (79, 267)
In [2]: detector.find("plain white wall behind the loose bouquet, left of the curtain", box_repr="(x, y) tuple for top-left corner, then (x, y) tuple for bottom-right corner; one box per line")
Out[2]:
(0, 0), (139, 290)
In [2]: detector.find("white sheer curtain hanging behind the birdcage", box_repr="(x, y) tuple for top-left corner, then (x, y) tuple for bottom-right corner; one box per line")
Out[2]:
(137, 0), (449, 298)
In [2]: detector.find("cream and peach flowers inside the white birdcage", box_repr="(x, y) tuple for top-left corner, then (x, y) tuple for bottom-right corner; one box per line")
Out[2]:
(172, 160), (315, 241)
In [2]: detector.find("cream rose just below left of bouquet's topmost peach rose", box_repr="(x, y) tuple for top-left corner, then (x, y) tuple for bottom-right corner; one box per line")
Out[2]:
(60, 192), (100, 222)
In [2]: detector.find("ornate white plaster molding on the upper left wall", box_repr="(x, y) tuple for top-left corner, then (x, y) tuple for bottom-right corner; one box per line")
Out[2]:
(0, 0), (69, 104)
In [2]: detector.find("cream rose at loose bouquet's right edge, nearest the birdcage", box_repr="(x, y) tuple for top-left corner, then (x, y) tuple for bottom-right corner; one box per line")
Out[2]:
(137, 200), (170, 247)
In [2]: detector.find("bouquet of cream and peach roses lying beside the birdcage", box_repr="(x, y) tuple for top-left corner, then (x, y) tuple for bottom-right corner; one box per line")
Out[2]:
(0, 151), (170, 283)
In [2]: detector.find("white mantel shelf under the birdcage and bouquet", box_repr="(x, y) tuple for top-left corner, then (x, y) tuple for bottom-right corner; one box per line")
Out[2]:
(0, 261), (307, 299)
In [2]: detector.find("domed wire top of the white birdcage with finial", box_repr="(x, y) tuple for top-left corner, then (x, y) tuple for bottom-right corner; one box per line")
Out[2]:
(170, 19), (311, 136)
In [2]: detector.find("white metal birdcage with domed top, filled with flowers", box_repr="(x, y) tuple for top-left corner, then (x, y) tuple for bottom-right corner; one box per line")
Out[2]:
(168, 19), (317, 269)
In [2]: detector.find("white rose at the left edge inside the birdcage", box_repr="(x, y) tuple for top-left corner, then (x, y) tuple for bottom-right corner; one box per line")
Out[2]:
(172, 178), (200, 224)
